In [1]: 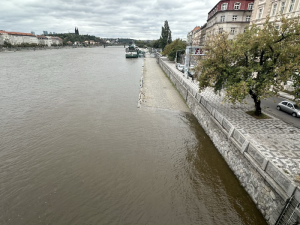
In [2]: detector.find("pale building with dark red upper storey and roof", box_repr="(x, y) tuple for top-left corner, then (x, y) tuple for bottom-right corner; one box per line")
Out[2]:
(204, 0), (254, 43)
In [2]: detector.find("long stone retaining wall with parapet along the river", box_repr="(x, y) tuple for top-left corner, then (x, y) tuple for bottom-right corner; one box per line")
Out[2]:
(157, 55), (300, 225)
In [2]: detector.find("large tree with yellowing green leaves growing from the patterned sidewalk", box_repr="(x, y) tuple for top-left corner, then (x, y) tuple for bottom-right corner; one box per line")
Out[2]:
(197, 18), (300, 116)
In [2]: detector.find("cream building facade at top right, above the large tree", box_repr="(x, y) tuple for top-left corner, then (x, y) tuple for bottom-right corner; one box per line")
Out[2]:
(250, 0), (300, 26)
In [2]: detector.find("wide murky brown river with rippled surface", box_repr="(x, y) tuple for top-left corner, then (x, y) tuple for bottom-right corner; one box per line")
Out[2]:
(0, 47), (264, 225)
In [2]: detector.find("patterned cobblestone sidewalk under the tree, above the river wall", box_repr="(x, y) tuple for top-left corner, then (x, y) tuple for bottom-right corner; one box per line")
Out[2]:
(165, 61), (300, 180)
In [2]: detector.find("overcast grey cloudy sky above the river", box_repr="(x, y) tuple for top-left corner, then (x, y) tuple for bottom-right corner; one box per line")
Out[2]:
(0, 0), (218, 40)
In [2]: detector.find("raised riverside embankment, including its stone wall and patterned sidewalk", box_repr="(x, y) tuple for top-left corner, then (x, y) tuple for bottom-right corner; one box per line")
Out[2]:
(157, 56), (300, 224)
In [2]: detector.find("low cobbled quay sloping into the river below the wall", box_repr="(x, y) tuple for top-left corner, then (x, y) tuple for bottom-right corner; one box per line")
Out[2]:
(141, 54), (190, 112)
